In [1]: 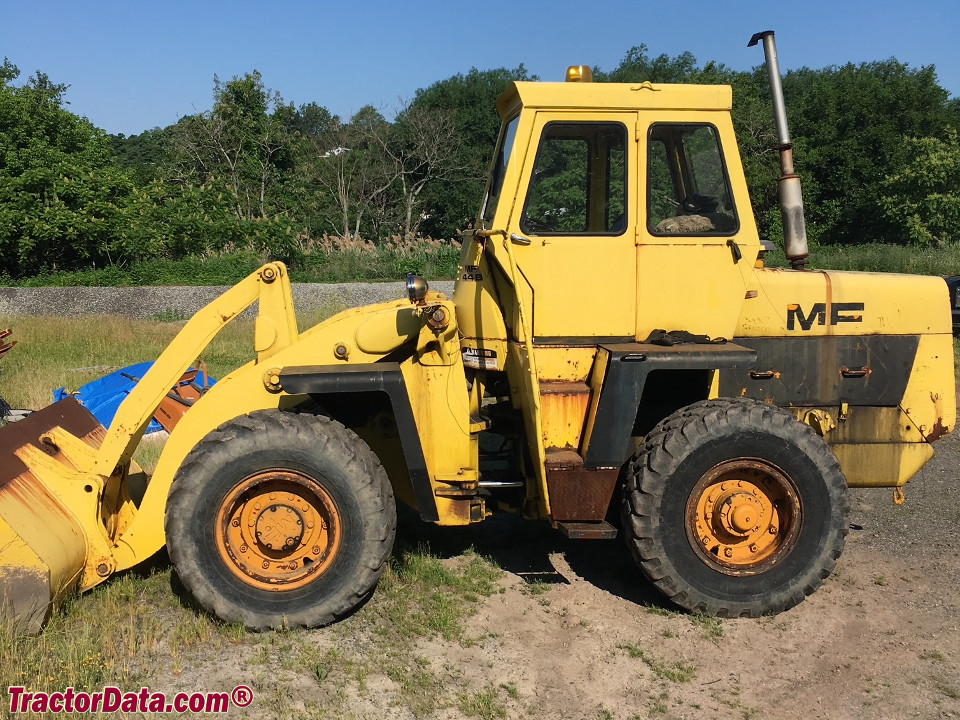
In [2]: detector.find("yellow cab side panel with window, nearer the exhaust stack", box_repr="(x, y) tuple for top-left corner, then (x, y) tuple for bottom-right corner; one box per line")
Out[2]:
(637, 116), (759, 339)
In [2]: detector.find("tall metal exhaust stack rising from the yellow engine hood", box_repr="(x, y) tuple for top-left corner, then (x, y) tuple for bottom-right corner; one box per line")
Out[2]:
(747, 30), (809, 270)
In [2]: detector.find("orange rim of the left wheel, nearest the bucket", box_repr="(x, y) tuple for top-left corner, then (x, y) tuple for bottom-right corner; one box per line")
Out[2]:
(216, 470), (341, 591)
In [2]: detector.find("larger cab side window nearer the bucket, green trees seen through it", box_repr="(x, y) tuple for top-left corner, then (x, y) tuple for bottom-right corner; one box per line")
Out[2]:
(520, 122), (627, 235)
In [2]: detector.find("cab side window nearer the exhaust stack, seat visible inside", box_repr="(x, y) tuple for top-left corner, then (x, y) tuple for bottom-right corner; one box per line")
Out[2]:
(647, 123), (740, 235)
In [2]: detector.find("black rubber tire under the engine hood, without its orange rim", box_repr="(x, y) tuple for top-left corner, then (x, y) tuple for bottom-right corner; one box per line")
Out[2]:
(621, 398), (850, 617)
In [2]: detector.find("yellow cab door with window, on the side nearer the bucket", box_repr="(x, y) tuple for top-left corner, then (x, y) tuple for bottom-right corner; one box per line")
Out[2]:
(507, 112), (637, 345)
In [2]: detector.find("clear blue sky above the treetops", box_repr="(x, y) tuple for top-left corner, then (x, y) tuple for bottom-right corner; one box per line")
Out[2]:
(0, 0), (960, 135)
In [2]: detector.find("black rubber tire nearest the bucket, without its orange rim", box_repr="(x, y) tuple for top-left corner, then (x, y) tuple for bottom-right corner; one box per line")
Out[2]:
(164, 410), (397, 630)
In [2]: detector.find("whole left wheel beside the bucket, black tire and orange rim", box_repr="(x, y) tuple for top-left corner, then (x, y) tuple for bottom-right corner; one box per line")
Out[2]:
(164, 410), (396, 629)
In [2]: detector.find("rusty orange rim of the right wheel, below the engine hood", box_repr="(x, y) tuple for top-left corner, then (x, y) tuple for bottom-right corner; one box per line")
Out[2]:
(686, 458), (801, 575)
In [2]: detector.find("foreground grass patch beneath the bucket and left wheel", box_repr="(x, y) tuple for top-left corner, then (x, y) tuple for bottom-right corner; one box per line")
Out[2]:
(0, 543), (506, 719)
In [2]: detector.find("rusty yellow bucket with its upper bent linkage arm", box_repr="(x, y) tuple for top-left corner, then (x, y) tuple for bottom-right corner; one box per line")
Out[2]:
(0, 263), (298, 633)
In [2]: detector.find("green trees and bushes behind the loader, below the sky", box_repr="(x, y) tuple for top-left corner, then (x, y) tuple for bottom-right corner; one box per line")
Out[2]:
(0, 45), (960, 284)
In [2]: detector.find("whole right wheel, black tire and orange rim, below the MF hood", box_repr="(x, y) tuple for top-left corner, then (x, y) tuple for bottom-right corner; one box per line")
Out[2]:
(622, 399), (849, 617)
